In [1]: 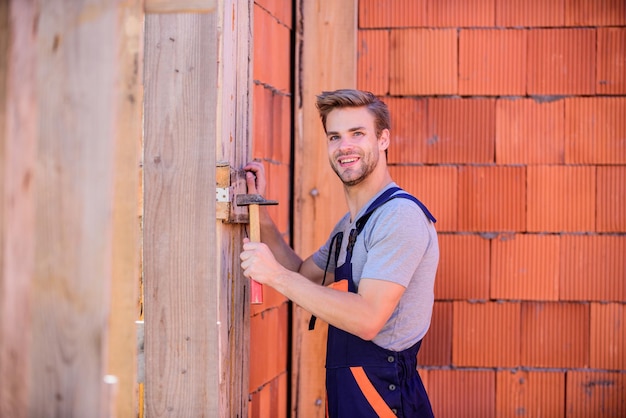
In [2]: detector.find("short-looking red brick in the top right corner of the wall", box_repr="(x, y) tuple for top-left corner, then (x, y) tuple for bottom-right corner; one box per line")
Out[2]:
(565, 0), (626, 26)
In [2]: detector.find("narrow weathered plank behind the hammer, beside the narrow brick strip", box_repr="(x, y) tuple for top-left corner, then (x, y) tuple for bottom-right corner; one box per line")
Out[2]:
(216, 0), (253, 417)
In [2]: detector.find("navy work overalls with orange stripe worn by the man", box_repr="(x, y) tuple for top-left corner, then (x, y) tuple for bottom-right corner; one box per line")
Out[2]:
(326, 187), (436, 418)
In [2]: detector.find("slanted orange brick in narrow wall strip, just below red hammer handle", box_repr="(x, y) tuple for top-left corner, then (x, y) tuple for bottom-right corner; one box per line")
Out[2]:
(250, 303), (289, 392)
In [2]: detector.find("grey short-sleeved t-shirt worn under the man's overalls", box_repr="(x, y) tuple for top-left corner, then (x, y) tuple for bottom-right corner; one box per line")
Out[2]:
(313, 183), (439, 351)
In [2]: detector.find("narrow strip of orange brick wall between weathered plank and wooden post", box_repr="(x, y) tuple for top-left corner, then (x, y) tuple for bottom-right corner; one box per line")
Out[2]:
(248, 0), (293, 418)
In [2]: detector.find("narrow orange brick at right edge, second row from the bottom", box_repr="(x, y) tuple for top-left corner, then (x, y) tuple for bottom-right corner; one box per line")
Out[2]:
(589, 303), (626, 370)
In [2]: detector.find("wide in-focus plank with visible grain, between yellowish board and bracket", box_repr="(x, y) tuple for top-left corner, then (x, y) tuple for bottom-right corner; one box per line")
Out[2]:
(143, 13), (221, 417)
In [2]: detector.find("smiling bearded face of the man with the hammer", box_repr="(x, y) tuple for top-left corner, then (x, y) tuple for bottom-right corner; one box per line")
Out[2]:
(326, 107), (387, 186)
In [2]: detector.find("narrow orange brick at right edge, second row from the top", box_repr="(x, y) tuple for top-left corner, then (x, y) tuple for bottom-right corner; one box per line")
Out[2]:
(596, 27), (626, 94)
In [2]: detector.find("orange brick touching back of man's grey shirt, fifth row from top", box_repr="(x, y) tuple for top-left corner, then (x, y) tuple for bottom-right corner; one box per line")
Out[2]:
(435, 234), (490, 300)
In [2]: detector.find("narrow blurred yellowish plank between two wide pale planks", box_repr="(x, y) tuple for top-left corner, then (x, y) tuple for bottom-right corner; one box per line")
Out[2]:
(107, 0), (144, 418)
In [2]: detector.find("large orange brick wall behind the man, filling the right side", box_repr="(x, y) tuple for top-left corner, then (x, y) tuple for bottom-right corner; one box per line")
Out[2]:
(357, 0), (626, 418)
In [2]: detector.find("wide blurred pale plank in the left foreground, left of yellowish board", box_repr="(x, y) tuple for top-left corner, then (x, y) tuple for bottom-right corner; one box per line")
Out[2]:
(26, 0), (119, 417)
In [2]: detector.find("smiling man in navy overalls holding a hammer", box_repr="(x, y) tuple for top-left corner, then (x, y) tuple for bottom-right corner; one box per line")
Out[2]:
(241, 90), (439, 418)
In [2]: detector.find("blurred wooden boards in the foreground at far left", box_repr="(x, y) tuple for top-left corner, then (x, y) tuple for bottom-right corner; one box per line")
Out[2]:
(0, 0), (142, 417)
